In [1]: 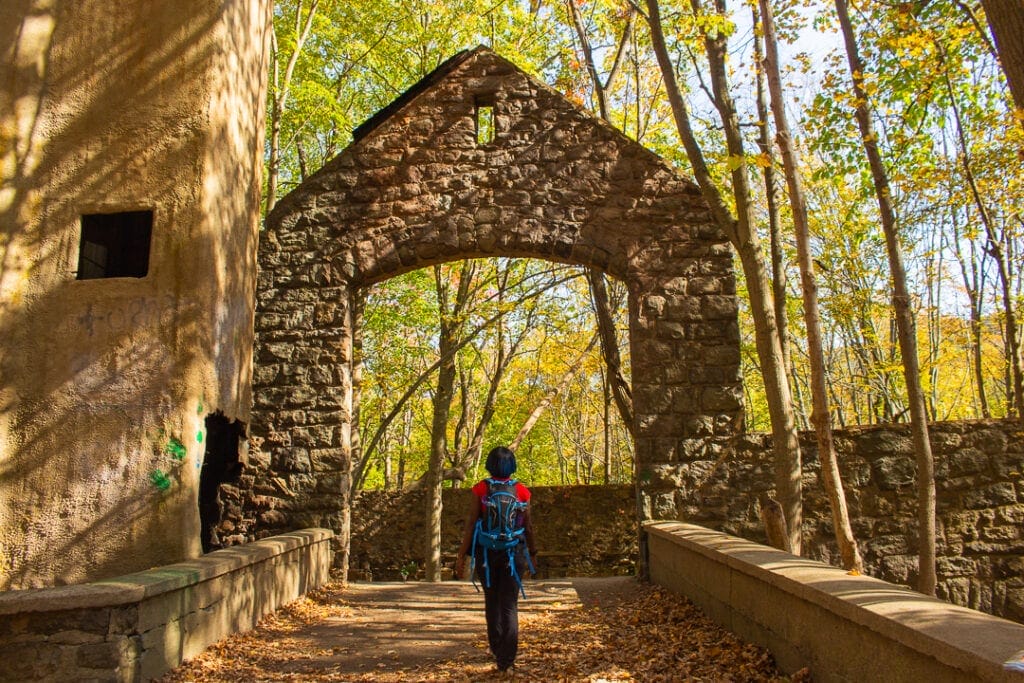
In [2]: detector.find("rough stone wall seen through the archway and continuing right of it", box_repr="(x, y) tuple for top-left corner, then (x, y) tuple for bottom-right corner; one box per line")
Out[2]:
(352, 420), (1024, 622)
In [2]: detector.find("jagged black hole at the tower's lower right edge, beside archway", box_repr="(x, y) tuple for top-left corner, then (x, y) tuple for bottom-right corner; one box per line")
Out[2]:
(199, 411), (246, 553)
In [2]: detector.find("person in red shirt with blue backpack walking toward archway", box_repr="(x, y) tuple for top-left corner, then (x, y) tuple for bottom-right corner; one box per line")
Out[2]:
(455, 446), (537, 674)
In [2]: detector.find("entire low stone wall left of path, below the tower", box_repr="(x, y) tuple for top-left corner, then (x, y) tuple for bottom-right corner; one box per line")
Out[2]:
(0, 529), (333, 683)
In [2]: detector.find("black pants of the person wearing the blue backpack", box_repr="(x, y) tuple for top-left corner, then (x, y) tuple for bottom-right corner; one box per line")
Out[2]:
(476, 548), (519, 671)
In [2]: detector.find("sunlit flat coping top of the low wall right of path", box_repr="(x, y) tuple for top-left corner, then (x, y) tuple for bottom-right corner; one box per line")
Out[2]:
(643, 521), (1024, 681)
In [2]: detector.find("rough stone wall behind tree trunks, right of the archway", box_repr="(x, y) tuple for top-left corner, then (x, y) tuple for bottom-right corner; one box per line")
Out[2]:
(673, 420), (1024, 621)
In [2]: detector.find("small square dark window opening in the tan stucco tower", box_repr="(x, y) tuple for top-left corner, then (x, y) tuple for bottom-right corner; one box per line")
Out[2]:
(78, 211), (153, 280)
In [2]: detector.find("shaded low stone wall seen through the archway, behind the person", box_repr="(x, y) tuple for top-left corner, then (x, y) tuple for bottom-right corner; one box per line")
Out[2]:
(349, 485), (638, 581)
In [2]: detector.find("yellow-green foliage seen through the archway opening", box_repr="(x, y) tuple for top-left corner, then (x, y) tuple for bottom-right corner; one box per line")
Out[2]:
(360, 259), (632, 487)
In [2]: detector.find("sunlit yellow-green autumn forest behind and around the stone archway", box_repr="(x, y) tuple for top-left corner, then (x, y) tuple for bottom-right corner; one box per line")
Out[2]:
(265, 0), (1024, 497)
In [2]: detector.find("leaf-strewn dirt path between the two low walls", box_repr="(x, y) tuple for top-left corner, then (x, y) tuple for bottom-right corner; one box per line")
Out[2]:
(163, 578), (786, 683)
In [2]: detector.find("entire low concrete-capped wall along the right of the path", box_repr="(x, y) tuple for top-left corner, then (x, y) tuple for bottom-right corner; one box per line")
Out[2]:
(644, 522), (1024, 681)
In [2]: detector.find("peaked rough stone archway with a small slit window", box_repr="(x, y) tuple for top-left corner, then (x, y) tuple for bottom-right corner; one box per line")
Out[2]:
(246, 48), (742, 566)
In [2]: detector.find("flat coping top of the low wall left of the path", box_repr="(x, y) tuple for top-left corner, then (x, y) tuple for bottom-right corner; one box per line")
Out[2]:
(0, 528), (334, 614)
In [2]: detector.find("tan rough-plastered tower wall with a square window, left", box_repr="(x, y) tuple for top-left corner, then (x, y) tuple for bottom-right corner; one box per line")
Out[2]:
(0, 0), (270, 589)
